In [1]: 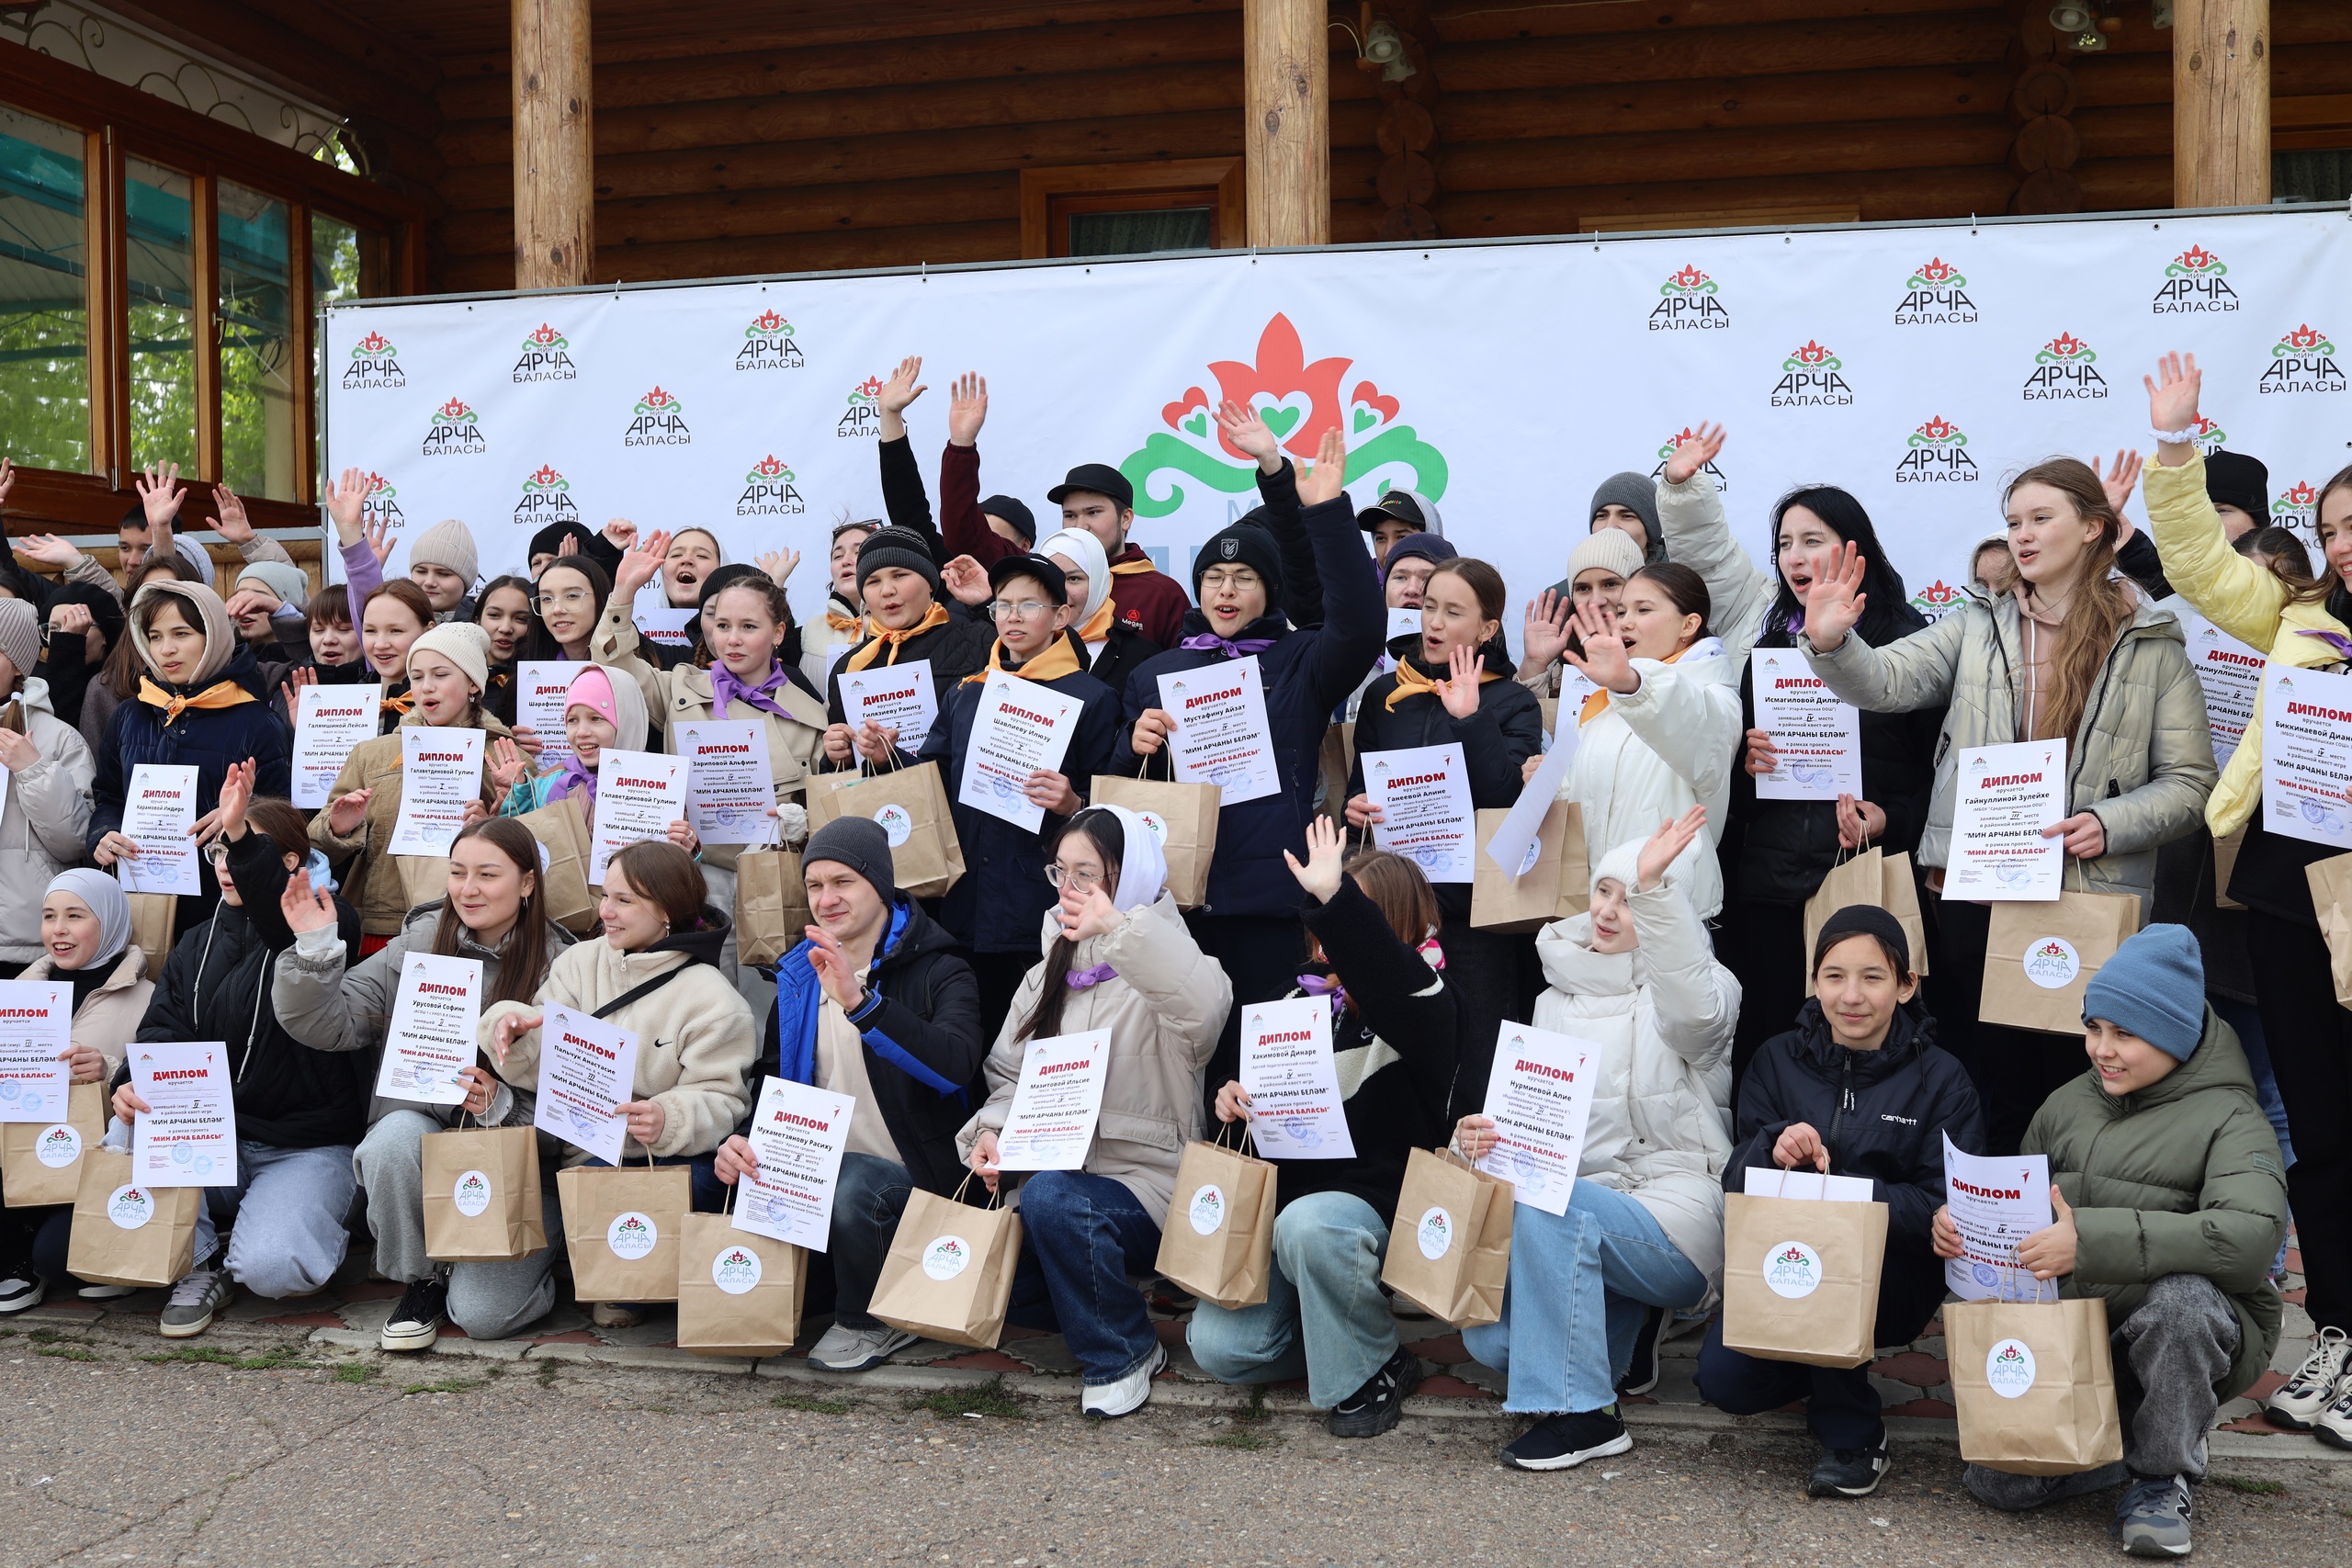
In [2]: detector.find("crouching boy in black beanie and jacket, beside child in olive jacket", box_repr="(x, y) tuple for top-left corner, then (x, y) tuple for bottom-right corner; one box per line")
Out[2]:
(1698, 905), (1985, 1497)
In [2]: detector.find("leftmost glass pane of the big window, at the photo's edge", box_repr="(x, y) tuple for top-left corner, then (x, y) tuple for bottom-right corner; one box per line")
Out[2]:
(0, 106), (89, 472)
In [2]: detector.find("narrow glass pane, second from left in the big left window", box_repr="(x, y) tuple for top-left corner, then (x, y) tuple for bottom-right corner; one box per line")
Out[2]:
(122, 157), (195, 470)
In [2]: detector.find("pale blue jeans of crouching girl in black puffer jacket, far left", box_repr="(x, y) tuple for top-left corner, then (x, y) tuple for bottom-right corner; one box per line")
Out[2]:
(195, 1138), (360, 1300)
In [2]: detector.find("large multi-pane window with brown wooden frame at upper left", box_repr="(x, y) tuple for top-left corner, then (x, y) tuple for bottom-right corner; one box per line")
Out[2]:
(0, 45), (424, 534)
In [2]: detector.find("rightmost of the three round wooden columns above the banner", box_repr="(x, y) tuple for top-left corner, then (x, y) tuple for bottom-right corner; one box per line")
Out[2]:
(2173, 0), (2269, 207)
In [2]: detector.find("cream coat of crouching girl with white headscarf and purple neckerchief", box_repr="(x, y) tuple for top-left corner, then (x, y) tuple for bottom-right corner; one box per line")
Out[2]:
(955, 894), (1232, 1215)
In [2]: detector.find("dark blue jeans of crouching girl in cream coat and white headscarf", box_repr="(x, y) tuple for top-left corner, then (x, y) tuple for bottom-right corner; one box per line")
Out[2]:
(1004, 1170), (1159, 1384)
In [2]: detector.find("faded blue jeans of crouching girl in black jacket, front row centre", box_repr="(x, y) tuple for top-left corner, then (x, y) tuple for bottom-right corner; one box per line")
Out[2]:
(1185, 1192), (1397, 1411)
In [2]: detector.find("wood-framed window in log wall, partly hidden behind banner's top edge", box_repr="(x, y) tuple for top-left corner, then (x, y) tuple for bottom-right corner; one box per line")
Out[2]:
(1021, 157), (1244, 256)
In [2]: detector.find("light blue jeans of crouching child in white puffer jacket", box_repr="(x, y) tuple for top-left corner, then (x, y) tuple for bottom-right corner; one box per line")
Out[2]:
(1463, 1180), (1708, 1416)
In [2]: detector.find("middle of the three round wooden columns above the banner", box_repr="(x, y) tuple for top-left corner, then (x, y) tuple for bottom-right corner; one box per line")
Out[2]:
(1250, 0), (1331, 244)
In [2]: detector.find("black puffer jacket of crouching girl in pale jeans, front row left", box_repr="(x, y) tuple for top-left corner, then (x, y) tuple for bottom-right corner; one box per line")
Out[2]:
(122, 828), (377, 1149)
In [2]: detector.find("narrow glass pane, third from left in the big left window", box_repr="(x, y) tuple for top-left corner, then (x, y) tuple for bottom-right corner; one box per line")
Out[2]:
(217, 179), (297, 501)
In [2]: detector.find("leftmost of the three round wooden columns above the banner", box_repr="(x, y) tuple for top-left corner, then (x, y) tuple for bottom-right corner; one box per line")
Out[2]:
(513, 0), (595, 289)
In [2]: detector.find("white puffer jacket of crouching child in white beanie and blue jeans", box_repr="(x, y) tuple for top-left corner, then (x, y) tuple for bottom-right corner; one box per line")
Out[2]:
(1536, 864), (1740, 1300)
